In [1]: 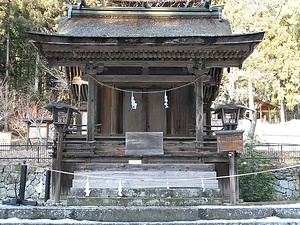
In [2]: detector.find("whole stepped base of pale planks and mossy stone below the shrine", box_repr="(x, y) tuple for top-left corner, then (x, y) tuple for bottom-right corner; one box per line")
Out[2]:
(67, 163), (223, 206)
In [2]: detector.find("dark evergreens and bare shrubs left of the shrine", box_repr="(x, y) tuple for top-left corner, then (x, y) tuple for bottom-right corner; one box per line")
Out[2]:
(0, 0), (68, 133)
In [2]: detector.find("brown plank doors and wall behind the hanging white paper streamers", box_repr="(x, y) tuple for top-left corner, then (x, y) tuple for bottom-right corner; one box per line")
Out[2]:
(95, 86), (195, 136)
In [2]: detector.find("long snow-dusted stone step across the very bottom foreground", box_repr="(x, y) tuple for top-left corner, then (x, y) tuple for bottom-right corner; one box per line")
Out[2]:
(0, 204), (300, 225)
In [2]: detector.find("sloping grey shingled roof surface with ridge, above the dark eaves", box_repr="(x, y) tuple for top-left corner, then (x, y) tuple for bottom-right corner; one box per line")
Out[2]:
(58, 7), (232, 37)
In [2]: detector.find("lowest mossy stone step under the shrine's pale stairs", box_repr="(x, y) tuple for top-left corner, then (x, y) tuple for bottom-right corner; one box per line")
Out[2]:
(67, 196), (222, 207)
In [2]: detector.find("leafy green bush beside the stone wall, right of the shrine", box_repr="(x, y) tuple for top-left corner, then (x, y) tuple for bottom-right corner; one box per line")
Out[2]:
(238, 141), (275, 202)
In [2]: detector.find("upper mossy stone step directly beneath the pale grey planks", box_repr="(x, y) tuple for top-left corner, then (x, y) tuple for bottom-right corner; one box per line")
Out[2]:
(71, 188), (221, 198)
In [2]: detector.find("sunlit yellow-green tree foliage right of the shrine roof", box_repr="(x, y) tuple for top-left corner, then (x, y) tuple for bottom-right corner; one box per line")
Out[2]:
(218, 0), (300, 121)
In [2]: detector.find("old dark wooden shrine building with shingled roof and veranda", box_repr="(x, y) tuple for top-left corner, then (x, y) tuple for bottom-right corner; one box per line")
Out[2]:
(28, 3), (264, 200)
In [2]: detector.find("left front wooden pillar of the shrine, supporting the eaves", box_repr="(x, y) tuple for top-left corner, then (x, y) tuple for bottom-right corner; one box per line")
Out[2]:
(86, 75), (97, 141)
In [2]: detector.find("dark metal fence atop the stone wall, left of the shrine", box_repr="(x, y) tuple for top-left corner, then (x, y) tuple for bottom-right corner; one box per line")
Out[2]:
(0, 143), (52, 163)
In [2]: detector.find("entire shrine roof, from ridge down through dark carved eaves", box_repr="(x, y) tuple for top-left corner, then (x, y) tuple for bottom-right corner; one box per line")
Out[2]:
(28, 6), (264, 107)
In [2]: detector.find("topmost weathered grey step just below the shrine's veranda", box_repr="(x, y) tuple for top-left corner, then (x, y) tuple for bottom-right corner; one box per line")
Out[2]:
(76, 163), (215, 171)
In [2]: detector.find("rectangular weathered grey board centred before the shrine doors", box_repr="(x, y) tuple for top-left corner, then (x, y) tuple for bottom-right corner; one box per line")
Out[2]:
(125, 132), (164, 155)
